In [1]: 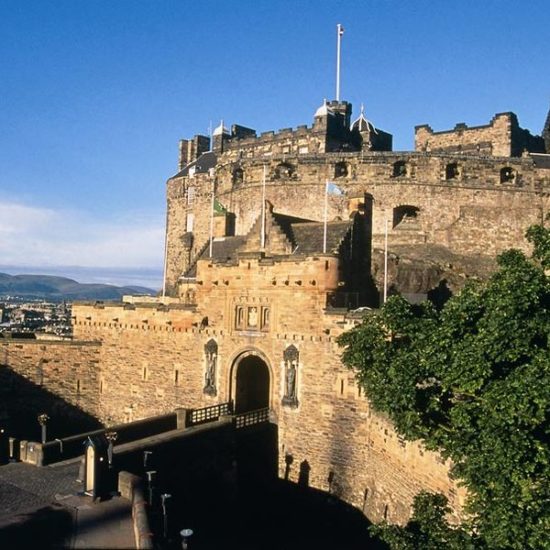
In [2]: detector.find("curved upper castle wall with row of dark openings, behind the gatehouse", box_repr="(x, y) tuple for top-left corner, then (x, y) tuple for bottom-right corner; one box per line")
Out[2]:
(167, 153), (550, 292)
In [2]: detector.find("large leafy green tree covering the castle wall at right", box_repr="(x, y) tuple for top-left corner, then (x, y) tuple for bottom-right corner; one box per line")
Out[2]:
(339, 226), (550, 549)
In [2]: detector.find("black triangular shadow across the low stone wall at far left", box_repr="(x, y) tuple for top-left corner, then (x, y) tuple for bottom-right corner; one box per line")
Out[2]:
(0, 365), (102, 441)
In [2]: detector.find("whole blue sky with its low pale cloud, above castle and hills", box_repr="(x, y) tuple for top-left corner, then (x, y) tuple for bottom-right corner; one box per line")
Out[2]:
(0, 0), (550, 288)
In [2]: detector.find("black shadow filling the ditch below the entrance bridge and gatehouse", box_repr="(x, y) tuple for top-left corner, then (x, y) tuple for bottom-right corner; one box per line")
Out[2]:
(147, 424), (387, 550)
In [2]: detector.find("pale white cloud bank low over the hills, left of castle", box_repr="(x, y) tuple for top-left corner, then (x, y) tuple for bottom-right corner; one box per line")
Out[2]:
(0, 200), (164, 268)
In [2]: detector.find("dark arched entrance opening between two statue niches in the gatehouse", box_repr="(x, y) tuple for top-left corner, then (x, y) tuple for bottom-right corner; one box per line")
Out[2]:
(233, 353), (271, 413)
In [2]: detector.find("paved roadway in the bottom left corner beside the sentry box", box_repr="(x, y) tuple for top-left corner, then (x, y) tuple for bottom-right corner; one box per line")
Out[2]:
(0, 461), (135, 550)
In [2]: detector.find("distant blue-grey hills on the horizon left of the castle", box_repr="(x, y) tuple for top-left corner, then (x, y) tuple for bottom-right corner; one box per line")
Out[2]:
(0, 273), (156, 301)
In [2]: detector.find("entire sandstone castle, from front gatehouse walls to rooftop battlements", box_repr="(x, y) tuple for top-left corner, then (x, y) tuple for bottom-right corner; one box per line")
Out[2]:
(1, 101), (550, 522)
